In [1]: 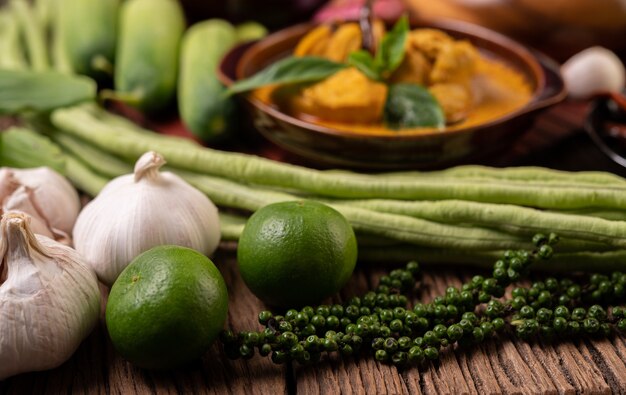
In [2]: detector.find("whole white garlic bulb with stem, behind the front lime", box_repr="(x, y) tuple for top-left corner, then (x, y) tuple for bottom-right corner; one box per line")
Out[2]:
(73, 152), (220, 285)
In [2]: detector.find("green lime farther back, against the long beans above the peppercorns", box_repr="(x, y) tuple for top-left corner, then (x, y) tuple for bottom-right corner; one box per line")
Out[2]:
(237, 201), (357, 307)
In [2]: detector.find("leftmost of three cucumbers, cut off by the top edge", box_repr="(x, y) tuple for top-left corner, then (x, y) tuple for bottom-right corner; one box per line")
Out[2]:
(54, 0), (120, 79)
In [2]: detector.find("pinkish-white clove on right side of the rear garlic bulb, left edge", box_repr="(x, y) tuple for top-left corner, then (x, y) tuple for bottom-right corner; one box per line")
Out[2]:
(10, 167), (81, 235)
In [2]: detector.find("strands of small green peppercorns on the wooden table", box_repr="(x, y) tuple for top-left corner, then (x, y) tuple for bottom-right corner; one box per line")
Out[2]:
(220, 234), (626, 367)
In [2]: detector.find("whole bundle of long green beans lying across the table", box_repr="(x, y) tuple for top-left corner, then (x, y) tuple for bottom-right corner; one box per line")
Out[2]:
(5, 104), (626, 271)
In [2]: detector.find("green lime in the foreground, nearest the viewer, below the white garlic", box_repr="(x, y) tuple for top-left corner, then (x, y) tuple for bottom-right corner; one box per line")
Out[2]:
(106, 246), (228, 369)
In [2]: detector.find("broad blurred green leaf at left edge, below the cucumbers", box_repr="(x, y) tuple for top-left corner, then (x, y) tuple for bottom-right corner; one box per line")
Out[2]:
(0, 70), (96, 114)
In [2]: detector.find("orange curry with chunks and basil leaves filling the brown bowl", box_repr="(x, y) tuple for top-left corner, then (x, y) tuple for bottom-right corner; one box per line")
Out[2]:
(235, 20), (533, 135)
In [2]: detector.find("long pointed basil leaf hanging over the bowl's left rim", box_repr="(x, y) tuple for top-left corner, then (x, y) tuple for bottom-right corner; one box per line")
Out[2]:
(226, 56), (347, 95)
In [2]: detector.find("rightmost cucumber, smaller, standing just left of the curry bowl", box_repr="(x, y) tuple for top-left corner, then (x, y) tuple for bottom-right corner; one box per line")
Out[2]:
(178, 19), (237, 141)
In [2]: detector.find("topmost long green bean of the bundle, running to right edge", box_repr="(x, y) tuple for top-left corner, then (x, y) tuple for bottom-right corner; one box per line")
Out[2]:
(52, 107), (626, 209)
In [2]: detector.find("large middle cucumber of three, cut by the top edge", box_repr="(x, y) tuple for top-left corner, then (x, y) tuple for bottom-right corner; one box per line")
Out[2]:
(111, 0), (184, 112)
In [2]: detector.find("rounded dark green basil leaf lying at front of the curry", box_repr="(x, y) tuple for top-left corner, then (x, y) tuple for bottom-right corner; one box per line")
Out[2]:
(383, 84), (446, 129)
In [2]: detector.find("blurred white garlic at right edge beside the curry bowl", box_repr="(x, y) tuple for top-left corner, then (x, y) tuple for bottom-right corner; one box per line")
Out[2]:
(561, 47), (626, 99)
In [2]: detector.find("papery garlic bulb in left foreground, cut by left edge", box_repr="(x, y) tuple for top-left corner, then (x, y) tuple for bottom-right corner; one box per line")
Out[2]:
(0, 212), (100, 380)
